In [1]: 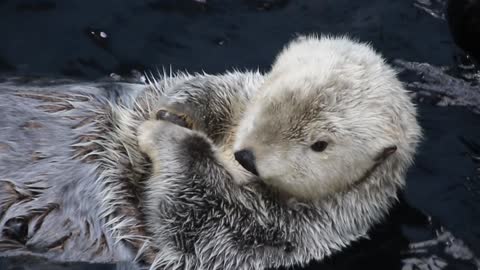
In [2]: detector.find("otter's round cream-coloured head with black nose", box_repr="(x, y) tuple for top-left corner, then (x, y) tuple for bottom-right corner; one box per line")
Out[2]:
(234, 37), (421, 199)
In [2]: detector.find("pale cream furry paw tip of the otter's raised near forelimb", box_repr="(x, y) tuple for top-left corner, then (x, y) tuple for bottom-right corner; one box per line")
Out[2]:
(137, 120), (190, 155)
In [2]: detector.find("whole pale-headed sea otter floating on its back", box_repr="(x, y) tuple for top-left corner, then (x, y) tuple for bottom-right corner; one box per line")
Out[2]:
(0, 36), (421, 270)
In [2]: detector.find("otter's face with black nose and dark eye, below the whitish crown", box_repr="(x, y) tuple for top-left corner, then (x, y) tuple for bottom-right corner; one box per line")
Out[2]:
(235, 85), (382, 198)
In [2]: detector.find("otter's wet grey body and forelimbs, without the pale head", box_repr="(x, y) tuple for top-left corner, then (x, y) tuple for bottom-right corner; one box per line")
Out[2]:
(0, 35), (420, 270)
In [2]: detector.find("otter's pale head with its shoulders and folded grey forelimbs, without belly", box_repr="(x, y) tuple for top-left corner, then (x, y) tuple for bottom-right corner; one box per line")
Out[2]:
(134, 36), (421, 269)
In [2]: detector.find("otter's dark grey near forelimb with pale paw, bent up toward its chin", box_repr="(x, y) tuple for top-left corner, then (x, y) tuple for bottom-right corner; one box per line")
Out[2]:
(137, 120), (297, 269)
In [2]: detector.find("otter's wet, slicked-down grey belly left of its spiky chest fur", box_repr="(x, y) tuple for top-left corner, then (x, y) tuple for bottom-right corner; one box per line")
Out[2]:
(0, 79), (143, 262)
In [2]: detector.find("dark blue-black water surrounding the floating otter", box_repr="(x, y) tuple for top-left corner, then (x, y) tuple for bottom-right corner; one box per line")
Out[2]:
(0, 0), (480, 269)
